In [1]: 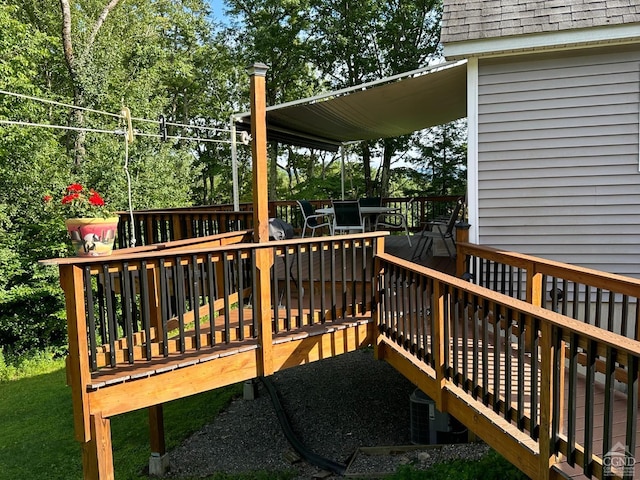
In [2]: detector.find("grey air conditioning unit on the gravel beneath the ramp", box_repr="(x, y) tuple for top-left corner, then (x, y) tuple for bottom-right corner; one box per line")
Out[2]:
(409, 388), (467, 445)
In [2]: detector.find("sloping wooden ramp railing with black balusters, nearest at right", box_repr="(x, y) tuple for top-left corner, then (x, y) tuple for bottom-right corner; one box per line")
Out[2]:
(377, 253), (640, 478)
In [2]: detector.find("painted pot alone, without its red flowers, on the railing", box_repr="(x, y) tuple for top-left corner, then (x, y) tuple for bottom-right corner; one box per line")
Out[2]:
(65, 217), (119, 257)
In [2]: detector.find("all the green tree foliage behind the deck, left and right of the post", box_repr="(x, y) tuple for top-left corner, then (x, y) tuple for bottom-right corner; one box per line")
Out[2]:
(0, 0), (464, 353)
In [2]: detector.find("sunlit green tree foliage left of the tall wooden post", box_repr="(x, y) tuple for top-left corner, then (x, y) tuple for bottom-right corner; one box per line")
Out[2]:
(0, 0), (241, 354)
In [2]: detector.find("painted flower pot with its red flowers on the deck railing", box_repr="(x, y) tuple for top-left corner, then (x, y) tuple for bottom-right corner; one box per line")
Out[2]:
(44, 183), (119, 257)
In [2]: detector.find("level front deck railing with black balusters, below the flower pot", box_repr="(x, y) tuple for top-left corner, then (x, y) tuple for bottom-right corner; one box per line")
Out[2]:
(52, 232), (386, 380)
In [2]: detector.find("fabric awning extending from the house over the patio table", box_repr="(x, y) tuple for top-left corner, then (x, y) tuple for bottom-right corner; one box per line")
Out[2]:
(234, 60), (467, 151)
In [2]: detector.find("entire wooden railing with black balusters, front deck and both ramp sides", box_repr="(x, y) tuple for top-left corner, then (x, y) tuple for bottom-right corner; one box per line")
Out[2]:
(45, 220), (640, 478)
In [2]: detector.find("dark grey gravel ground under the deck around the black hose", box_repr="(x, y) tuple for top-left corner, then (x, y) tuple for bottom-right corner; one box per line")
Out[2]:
(167, 349), (488, 480)
